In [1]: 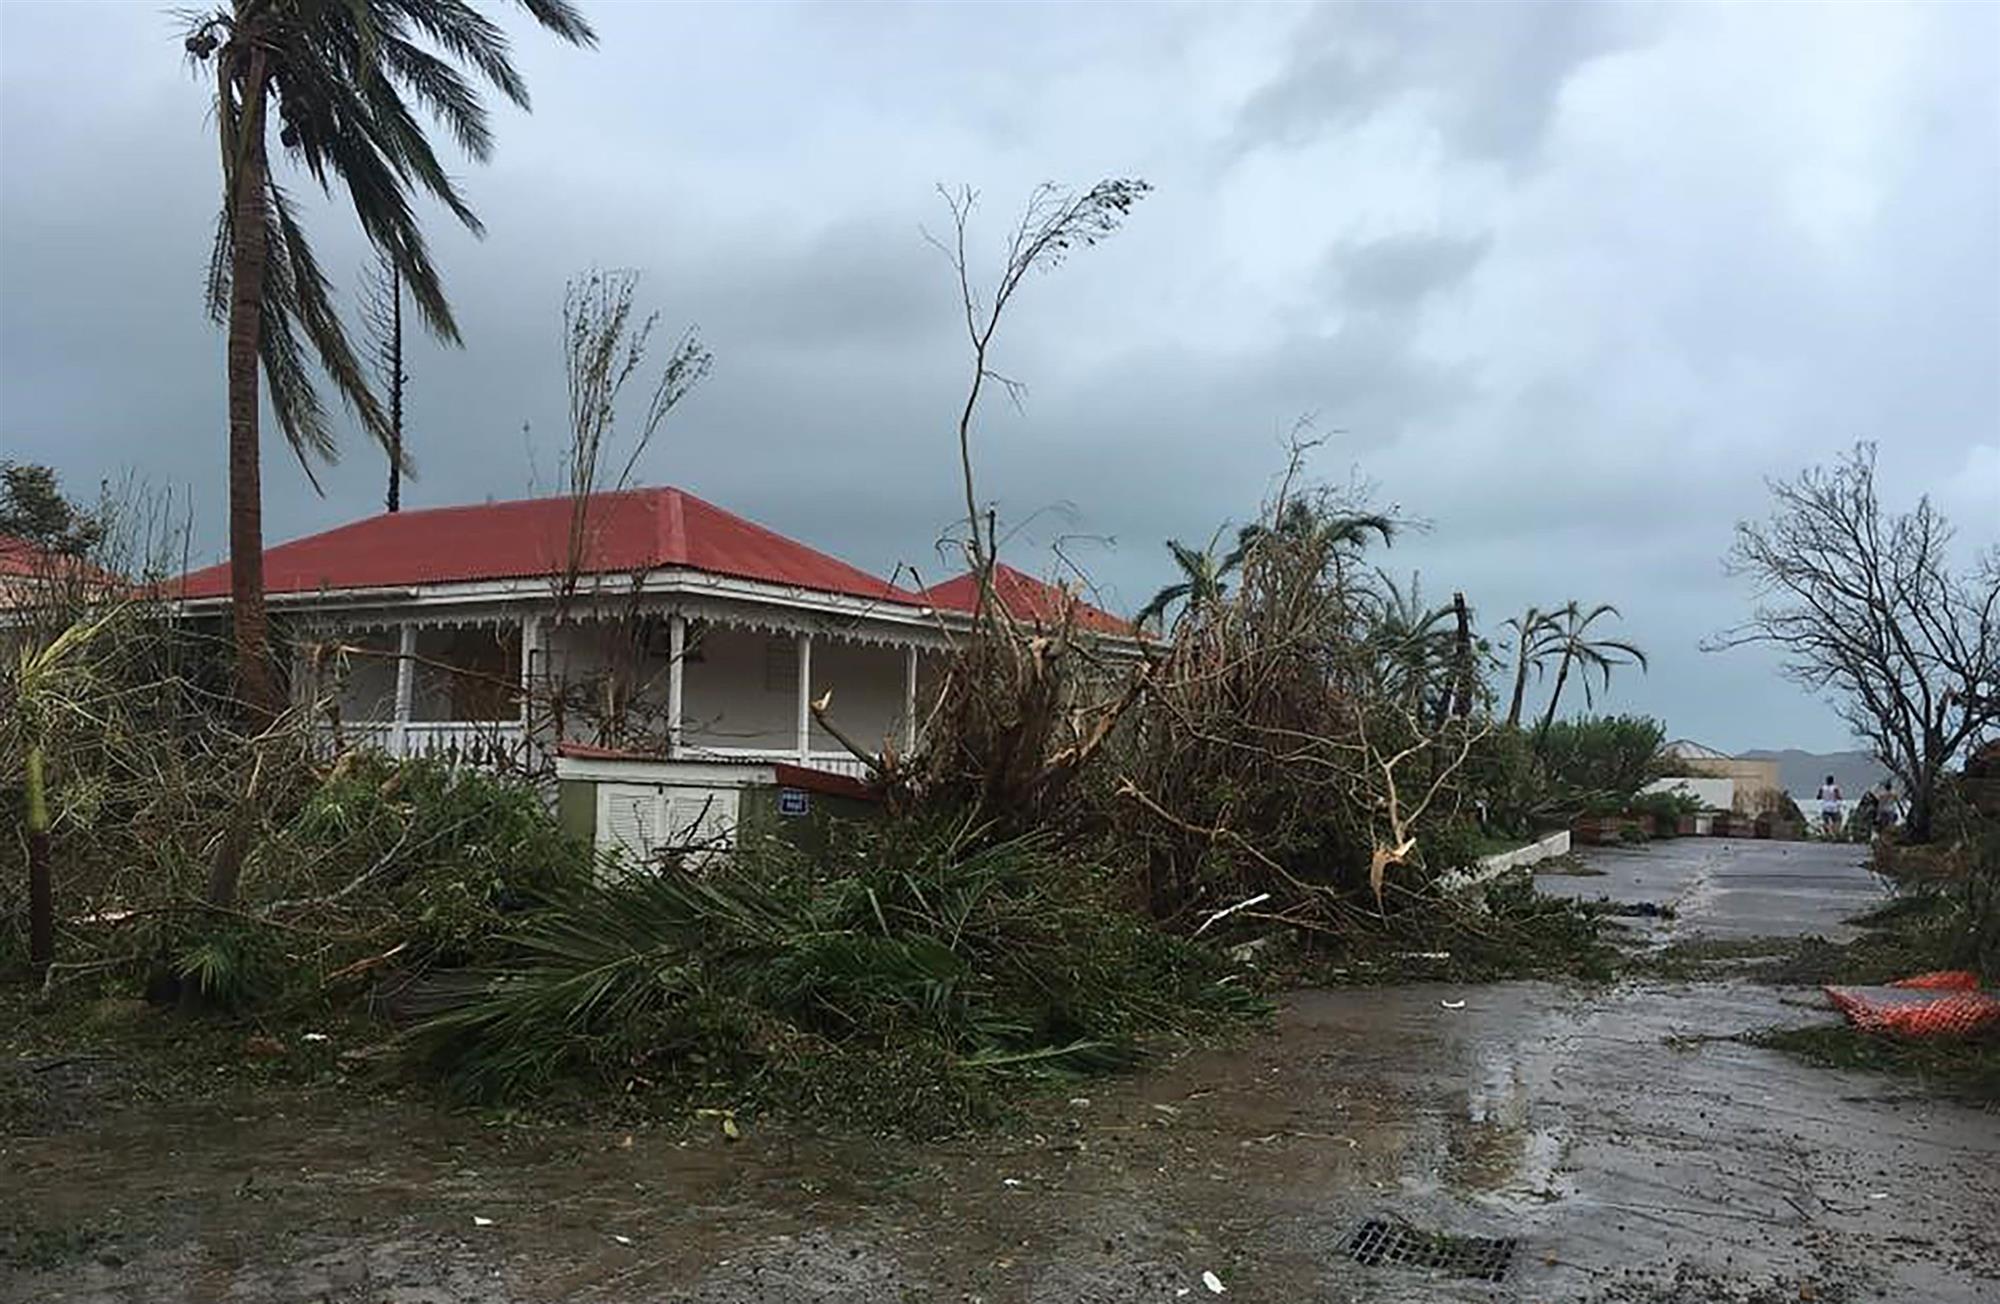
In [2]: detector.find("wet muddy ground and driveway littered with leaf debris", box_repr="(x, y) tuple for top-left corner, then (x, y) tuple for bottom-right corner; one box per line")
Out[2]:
(0, 840), (2000, 1304)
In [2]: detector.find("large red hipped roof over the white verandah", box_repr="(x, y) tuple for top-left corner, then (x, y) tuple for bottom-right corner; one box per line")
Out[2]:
(180, 488), (920, 604)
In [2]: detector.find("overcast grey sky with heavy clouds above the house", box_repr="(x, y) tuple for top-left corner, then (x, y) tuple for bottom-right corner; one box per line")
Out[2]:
(0, 0), (2000, 750)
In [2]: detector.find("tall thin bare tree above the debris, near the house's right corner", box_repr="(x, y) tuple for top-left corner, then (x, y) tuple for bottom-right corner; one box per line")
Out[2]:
(932, 178), (1152, 608)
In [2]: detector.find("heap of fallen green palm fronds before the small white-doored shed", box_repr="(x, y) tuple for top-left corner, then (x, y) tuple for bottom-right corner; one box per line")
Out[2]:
(412, 822), (1252, 1108)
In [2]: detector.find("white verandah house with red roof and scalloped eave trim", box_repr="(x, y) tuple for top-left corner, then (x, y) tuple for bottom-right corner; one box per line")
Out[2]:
(174, 488), (1132, 778)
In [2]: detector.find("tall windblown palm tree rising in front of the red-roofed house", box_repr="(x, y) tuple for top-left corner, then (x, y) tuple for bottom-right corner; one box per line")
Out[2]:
(184, 0), (596, 718)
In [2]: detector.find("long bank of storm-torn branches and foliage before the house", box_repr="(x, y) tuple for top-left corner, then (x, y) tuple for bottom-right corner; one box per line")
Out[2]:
(0, 464), (1664, 1132)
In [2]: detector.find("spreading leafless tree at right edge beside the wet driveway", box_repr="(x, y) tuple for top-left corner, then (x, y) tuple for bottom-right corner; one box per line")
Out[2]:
(1708, 444), (2000, 840)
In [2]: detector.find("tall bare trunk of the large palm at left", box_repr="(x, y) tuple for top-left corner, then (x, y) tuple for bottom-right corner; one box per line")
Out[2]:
(228, 52), (282, 728)
